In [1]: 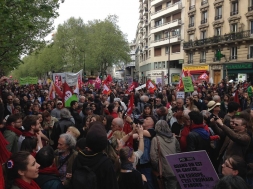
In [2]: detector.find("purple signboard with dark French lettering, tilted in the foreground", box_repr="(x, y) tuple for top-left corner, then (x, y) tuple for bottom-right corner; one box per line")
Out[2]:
(166, 150), (219, 189)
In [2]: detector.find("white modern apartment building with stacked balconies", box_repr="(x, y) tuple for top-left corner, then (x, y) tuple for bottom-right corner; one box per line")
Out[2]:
(135, 0), (185, 84)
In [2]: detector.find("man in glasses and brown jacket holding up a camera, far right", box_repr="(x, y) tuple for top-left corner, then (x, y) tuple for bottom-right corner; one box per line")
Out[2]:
(214, 116), (251, 173)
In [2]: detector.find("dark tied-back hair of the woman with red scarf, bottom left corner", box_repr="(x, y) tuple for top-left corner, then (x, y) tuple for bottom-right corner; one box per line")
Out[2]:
(5, 151), (30, 185)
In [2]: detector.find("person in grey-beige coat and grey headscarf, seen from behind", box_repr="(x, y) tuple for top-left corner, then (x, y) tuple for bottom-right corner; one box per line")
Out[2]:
(150, 120), (181, 189)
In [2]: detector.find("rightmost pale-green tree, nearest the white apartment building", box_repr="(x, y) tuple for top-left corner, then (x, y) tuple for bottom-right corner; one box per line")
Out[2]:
(86, 15), (131, 74)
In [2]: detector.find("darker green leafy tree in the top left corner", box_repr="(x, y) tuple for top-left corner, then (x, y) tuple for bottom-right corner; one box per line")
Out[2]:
(0, 0), (59, 67)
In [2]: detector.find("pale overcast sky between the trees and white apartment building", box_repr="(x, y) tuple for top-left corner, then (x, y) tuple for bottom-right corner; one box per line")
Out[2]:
(51, 0), (139, 42)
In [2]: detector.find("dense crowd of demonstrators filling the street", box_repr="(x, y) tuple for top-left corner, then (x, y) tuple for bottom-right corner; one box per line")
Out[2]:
(0, 75), (253, 189)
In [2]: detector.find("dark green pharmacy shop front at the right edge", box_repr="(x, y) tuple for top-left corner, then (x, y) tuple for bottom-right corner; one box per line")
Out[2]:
(223, 62), (253, 82)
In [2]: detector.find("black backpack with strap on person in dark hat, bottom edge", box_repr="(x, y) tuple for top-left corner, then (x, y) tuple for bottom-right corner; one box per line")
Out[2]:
(71, 156), (108, 189)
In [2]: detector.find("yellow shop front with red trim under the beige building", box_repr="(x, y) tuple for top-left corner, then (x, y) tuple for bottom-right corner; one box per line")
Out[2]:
(183, 65), (209, 81)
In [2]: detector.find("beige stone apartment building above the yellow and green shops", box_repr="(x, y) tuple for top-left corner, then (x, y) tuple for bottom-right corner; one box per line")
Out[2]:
(183, 0), (253, 84)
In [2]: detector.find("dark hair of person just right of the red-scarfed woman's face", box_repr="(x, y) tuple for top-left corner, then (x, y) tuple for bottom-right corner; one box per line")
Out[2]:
(36, 146), (54, 169)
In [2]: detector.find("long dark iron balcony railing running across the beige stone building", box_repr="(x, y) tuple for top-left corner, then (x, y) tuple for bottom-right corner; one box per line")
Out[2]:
(184, 30), (251, 49)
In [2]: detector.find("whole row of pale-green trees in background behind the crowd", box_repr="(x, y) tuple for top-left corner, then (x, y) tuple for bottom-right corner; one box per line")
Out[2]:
(13, 16), (131, 78)
